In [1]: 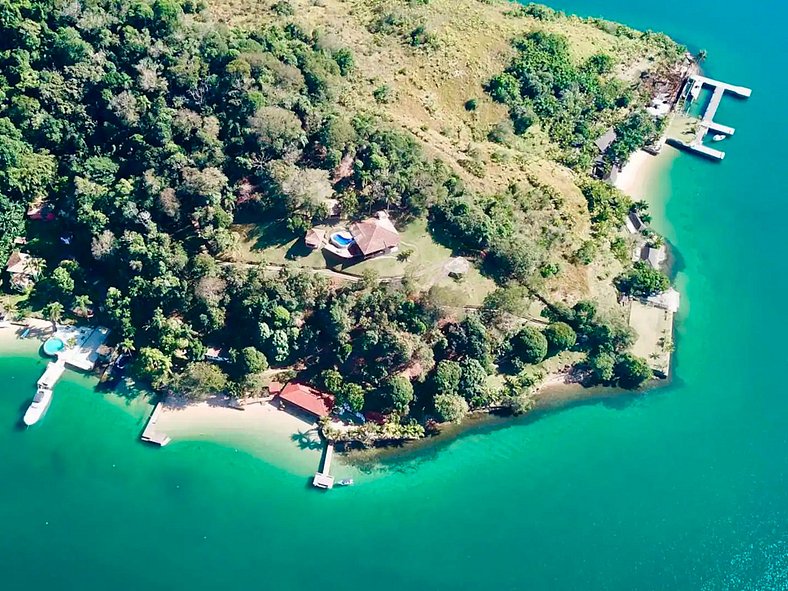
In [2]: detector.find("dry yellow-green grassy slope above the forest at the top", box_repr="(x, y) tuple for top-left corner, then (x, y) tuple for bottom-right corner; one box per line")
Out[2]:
(209, 0), (680, 307)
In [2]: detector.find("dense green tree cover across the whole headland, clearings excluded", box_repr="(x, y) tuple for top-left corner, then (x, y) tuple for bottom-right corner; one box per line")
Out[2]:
(0, 0), (662, 434)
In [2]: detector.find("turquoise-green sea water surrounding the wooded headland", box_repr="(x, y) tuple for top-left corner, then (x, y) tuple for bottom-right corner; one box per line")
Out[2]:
(0, 0), (788, 591)
